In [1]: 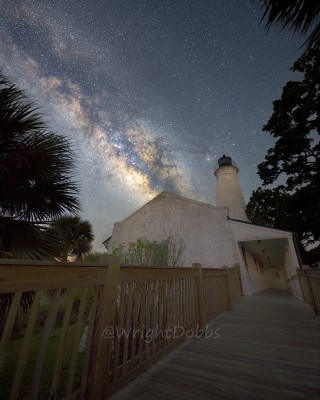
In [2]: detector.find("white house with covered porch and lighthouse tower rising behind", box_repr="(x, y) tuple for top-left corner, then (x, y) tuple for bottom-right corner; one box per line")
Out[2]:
(104, 156), (302, 298)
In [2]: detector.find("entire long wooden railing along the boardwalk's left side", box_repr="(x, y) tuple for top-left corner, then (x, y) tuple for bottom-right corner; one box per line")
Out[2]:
(0, 256), (241, 400)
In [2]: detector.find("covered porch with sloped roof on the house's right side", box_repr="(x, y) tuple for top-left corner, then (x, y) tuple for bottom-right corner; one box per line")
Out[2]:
(229, 219), (302, 299)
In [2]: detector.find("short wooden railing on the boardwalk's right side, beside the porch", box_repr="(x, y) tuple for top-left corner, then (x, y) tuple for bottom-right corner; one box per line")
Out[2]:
(297, 268), (320, 315)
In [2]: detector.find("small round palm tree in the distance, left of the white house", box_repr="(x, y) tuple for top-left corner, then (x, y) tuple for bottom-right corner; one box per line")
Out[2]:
(49, 215), (94, 262)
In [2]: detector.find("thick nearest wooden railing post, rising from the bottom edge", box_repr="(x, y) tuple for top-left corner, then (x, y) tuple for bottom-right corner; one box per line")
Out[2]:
(86, 255), (120, 400)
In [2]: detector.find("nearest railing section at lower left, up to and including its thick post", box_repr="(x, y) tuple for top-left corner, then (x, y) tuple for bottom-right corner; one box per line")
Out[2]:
(0, 256), (119, 400)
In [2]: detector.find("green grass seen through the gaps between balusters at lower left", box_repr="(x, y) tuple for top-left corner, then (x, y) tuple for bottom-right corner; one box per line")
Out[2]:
(0, 324), (83, 399)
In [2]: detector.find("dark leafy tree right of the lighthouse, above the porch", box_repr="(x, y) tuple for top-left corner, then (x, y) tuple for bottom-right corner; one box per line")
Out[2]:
(247, 51), (320, 263)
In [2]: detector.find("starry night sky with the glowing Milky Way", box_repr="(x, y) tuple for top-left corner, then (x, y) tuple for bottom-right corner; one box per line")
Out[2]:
(0, 0), (304, 250)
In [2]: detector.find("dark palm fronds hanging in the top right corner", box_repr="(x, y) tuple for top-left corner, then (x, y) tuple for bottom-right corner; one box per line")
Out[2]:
(262, 0), (320, 51)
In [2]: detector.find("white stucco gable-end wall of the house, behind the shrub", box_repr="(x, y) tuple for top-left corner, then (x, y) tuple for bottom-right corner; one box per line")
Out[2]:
(109, 192), (239, 268)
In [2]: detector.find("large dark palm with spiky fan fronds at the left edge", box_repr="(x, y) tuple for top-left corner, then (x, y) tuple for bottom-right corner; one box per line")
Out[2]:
(0, 73), (79, 259)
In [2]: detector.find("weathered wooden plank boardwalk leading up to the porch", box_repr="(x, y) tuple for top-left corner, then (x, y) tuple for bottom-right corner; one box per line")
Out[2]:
(112, 290), (320, 400)
